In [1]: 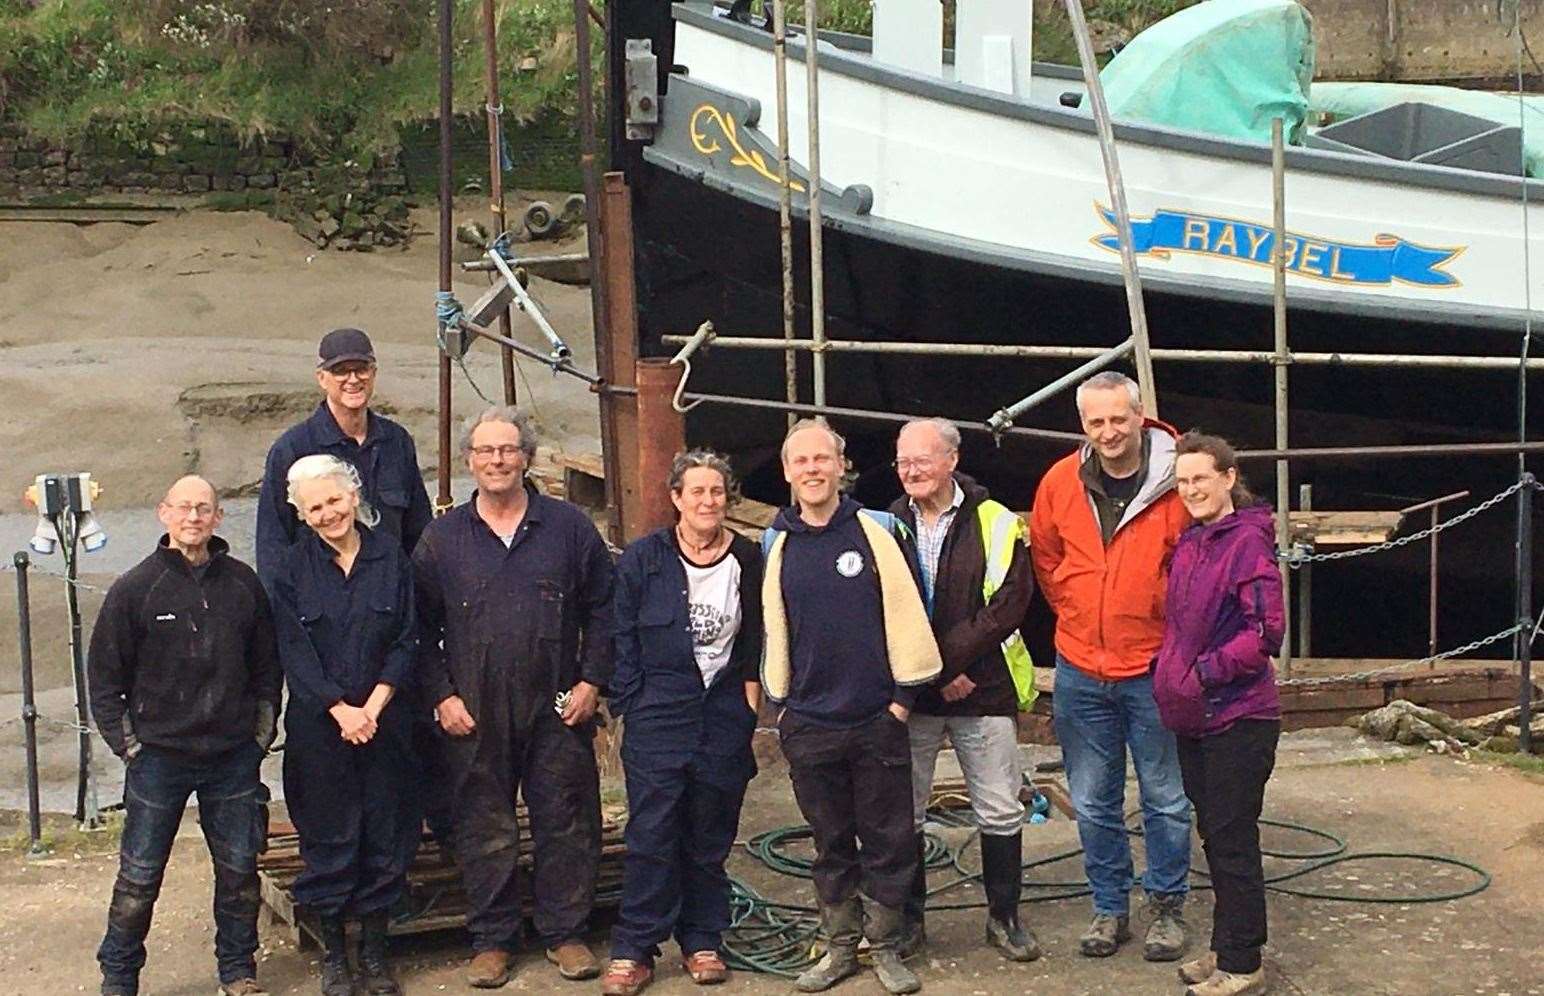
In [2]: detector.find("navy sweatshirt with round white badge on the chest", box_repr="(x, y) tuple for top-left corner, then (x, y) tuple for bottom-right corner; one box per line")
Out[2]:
(772, 497), (919, 727)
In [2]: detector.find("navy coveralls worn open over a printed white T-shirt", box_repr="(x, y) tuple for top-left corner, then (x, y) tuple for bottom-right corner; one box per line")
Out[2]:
(610, 528), (761, 964)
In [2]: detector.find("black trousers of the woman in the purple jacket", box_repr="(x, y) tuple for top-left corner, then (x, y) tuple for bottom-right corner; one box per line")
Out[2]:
(1178, 720), (1282, 973)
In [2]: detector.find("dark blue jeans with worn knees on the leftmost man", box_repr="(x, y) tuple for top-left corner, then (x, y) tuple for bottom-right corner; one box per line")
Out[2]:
(97, 741), (262, 991)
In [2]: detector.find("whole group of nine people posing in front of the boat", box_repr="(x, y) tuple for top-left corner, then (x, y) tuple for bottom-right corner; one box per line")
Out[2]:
(88, 329), (1283, 996)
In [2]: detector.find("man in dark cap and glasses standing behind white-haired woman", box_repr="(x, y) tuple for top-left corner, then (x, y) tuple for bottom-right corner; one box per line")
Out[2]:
(256, 329), (434, 584)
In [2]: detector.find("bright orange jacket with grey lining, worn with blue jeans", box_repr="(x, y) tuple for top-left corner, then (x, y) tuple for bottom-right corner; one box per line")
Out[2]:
(1030, 418), (1190, 681)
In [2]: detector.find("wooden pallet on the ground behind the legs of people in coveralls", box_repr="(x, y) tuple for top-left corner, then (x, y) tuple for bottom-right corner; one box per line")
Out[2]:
(258, 806), (627, 948)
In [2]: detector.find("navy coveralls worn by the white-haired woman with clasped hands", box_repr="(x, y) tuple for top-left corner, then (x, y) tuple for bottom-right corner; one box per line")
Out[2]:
(272, 527), (422, 917)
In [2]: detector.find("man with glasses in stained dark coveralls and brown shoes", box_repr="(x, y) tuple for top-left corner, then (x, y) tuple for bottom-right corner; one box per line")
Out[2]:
(412, 406), (613, 988)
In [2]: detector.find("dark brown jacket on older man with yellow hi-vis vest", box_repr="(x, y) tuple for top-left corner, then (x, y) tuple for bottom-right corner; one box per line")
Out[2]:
(889, 474), (1034, 717)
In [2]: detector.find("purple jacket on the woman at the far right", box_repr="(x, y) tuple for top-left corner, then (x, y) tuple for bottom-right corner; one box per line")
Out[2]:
(1153, 505), (1285, 737)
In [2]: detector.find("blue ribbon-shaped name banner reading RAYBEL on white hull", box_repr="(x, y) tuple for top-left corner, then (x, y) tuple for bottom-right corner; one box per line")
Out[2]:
(1093, 204), (1465, 287)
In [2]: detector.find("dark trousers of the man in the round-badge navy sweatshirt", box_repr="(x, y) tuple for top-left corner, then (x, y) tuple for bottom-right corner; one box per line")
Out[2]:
(778, 710), (917, 910)
